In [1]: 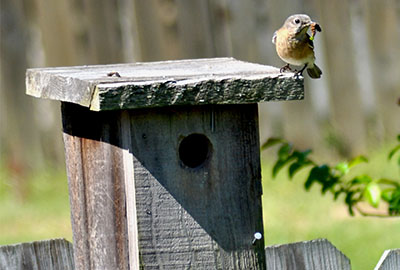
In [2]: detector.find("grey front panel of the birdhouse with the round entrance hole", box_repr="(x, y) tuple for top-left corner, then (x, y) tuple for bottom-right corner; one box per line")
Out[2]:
(123, 104), (263, 269)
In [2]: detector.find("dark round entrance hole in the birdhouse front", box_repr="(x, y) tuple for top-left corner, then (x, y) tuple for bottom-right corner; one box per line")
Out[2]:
(179, 134), (211, 168)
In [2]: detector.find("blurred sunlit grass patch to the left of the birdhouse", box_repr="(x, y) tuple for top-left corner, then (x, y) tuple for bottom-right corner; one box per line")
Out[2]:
(0, 163), (72, 245)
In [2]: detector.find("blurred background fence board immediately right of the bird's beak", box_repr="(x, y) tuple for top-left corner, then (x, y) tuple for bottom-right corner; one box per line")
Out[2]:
(318, 0), (366, 155)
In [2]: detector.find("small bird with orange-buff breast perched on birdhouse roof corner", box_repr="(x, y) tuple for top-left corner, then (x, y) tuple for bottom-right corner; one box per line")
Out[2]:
(272, 14), (322, 79)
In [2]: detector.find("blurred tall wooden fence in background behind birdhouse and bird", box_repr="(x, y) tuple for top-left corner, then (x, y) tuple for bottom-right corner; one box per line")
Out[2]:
(0, 0), (400, 169)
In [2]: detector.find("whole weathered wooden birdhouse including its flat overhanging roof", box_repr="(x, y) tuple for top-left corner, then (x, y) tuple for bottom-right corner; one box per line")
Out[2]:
(27, 58), (303, 269)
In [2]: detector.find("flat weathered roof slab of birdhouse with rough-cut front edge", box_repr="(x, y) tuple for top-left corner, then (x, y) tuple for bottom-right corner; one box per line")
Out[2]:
(26, 58), (304, 111)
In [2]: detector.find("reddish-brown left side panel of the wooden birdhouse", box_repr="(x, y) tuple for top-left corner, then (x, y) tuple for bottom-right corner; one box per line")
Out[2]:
(63, 104), (130, 270)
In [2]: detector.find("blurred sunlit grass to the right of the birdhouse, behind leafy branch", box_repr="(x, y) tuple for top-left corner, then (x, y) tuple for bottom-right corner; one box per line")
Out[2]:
(263, 144), (400, 270)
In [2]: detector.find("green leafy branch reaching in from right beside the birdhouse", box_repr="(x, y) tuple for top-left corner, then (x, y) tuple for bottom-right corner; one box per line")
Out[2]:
(261, 135), (400, 216)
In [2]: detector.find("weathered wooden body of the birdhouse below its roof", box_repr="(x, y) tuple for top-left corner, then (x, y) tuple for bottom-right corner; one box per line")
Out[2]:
(63, 103), (265, 269)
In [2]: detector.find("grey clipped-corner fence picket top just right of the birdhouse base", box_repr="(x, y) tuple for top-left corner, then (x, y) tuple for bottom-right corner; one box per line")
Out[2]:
(265, 239), (351, 270)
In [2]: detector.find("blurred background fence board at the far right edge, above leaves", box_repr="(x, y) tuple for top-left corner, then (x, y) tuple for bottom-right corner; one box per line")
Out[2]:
(362, 0), (400, 140)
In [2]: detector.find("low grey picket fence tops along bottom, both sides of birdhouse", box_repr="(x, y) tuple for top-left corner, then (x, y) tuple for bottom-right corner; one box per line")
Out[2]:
(0, 239), (400, 270)
